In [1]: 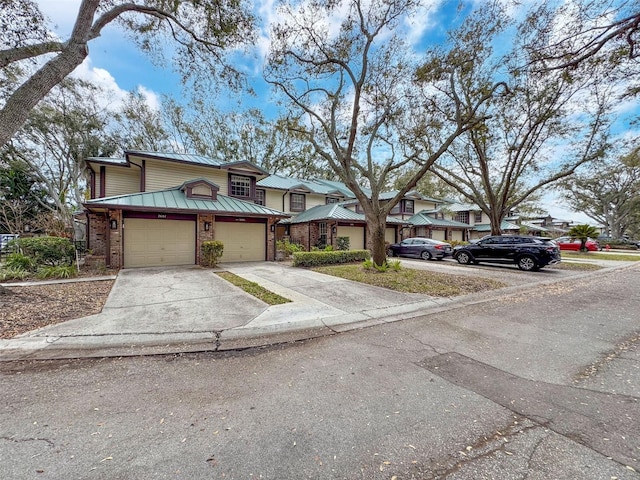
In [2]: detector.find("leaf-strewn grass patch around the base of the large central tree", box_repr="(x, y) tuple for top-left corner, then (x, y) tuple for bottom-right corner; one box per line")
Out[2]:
(312, 264), (507, 297)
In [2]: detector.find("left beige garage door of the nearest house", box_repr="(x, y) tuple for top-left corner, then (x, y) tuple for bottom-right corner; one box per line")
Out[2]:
(124, 218), (196, 268)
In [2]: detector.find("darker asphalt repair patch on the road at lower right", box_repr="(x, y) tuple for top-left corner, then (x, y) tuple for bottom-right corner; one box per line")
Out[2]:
(418, 353), (640, 470)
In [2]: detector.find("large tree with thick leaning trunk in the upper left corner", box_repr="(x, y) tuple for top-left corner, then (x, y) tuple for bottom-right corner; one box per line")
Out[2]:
(0, 0), (253, 145)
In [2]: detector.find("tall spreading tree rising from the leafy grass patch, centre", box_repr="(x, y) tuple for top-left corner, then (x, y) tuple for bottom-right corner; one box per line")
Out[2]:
(265, 0), (500, 264)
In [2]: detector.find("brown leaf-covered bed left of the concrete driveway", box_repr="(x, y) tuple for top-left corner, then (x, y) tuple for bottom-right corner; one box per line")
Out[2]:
(0, 280), (113, 339)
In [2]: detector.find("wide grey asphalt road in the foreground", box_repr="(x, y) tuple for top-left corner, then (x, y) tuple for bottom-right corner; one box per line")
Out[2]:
(0, 266), (640, 480)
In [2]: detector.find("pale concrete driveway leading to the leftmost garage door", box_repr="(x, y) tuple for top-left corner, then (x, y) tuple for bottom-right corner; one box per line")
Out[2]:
(20, 267), (267, 336)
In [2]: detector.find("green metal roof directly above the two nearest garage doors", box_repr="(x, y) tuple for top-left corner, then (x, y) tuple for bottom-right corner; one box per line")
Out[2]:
(84, 188), (288, 217)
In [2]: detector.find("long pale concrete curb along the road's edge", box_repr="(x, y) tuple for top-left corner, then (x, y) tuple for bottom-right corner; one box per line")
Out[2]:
(0, 264), (636, 362)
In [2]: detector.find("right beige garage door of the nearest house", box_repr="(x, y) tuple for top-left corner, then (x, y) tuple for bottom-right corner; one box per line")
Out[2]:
(216, 222), (266, 262)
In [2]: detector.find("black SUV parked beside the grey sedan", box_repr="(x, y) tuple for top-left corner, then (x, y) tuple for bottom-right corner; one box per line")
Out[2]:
(453, 235), (560, 272)
